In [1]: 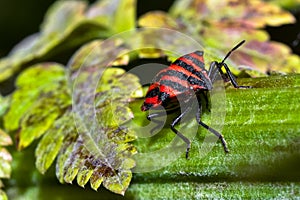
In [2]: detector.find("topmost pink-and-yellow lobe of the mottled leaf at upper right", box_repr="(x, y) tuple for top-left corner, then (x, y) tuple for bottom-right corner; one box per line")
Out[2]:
(170, 0), (295, 28)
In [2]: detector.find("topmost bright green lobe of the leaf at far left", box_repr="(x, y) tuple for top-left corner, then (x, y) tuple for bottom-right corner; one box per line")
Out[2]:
(4, 63), (65, 131)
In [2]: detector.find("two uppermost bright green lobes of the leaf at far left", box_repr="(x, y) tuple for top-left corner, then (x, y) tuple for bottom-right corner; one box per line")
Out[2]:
(4, 63), (71, 149)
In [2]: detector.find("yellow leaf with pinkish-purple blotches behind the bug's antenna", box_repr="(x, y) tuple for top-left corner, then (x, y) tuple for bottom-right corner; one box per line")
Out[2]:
(139, 0), (300, 75)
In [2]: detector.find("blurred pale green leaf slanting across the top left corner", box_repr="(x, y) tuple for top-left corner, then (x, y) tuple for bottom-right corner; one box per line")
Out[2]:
(0, 0), (135, 82)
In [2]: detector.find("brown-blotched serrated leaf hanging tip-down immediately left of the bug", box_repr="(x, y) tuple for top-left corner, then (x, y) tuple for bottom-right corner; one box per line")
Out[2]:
(62, 36), (141, 194)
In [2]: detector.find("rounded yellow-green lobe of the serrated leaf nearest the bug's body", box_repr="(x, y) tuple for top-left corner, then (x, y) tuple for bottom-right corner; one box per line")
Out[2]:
(95, 68), (140, 130)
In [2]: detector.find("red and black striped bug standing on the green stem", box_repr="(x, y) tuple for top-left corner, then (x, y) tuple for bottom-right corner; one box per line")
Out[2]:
(141, 40), (251, 158)
